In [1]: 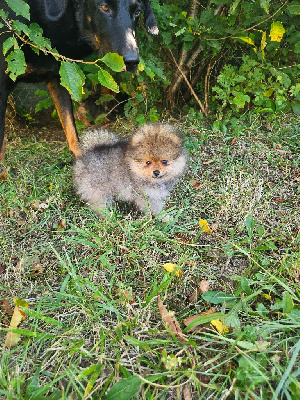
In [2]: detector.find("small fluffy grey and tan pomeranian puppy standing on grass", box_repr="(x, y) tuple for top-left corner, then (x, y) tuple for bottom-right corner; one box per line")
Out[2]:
(74, 123), (187, 216)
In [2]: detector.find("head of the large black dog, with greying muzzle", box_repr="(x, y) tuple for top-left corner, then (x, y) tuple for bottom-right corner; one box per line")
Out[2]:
(76, 0), (158, 71)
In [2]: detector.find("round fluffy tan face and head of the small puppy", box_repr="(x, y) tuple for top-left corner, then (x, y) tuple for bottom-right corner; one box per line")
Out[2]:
(127, 124), (186, 184)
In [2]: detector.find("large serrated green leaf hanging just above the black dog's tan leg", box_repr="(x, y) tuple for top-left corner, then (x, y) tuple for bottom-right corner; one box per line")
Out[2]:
(59, 61), (85, 101)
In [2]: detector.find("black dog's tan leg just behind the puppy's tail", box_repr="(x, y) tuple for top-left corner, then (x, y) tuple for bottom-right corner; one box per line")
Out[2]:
(47, 79), (81, 158)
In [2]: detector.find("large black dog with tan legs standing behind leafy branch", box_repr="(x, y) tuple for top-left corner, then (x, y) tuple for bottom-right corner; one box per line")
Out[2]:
(0, 0), (158, 160)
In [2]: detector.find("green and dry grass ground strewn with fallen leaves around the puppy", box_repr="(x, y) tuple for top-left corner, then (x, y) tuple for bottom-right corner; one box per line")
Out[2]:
(0, 114), (300, 400)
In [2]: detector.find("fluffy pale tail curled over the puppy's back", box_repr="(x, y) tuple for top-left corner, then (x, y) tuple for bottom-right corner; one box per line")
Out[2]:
(80, 128), (119, 154)
